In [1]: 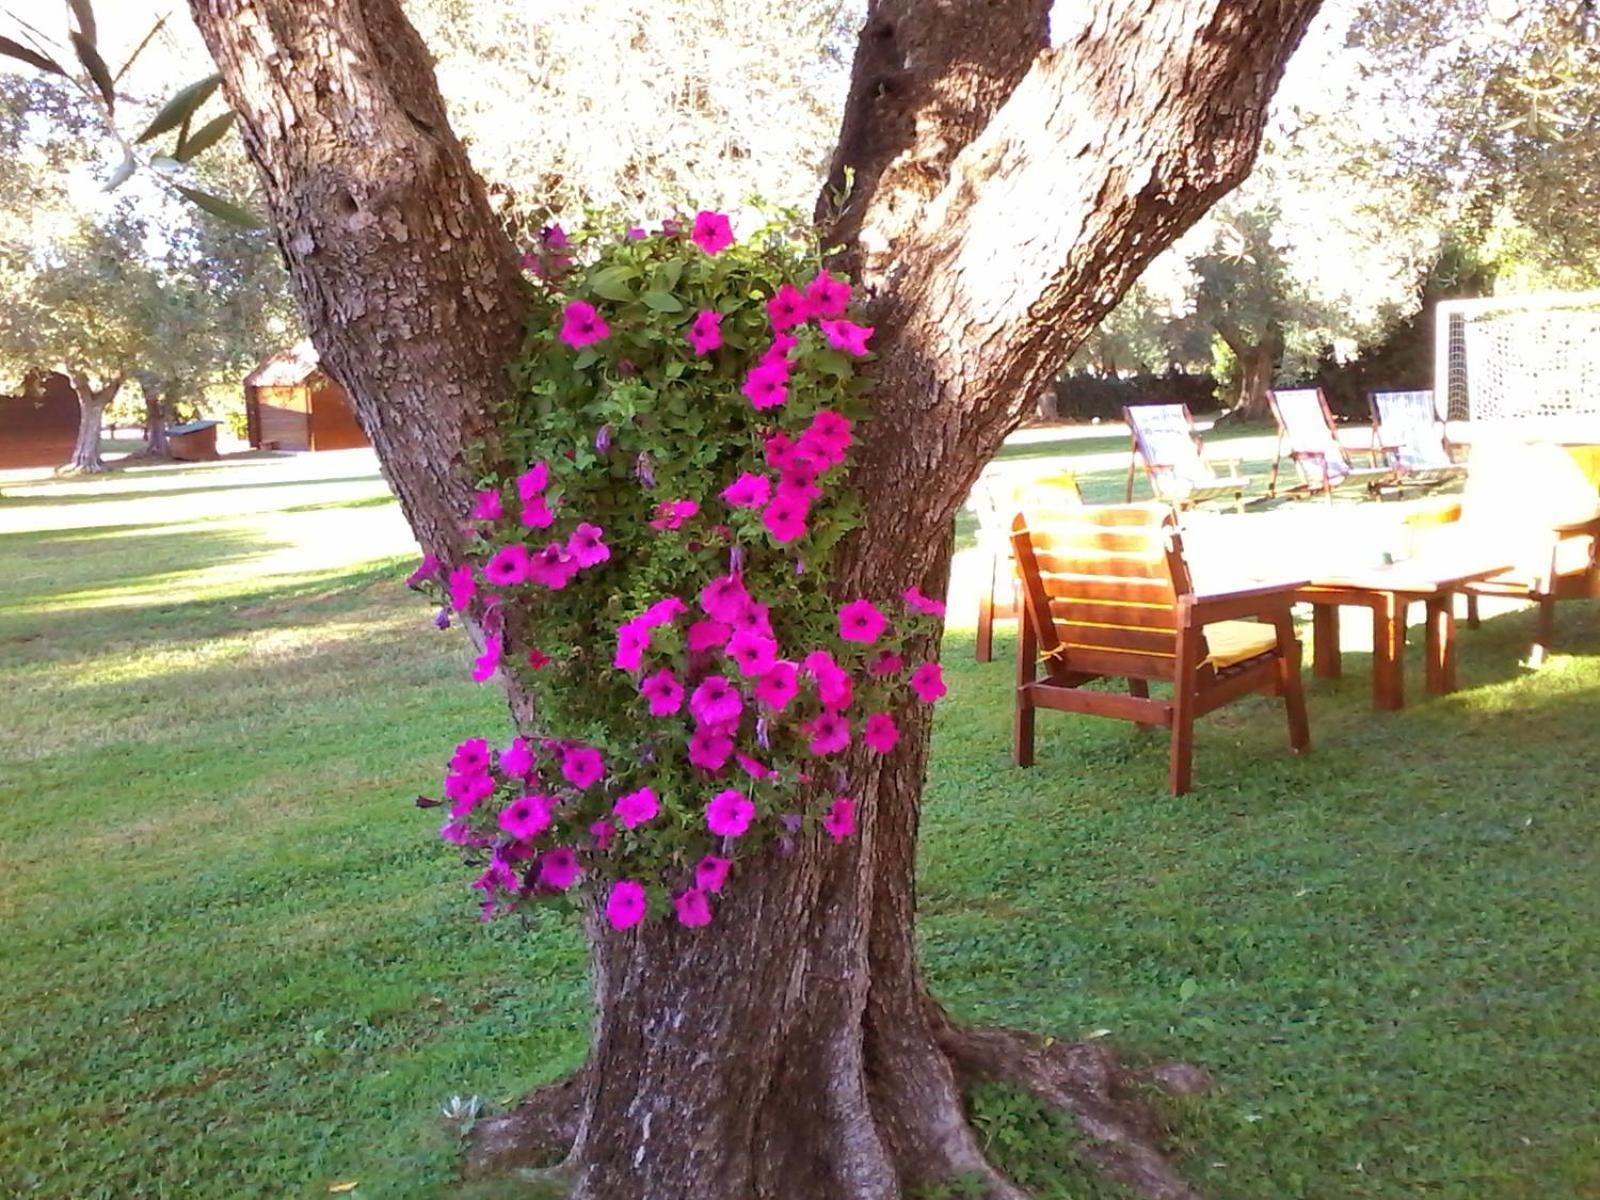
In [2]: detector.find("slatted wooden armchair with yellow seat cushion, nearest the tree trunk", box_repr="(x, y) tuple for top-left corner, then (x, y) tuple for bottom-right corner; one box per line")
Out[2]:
(1011, 504), (1310, 795)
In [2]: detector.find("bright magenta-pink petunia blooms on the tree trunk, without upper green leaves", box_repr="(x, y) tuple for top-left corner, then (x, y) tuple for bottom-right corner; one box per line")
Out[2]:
(411, 211), (946, 930)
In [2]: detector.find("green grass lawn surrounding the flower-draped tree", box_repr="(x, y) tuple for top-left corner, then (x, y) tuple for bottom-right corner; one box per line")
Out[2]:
(0, 445), (1600, 1200)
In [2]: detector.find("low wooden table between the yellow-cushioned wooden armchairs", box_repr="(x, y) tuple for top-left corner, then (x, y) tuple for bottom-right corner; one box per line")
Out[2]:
(1294, 558), (1510, 710)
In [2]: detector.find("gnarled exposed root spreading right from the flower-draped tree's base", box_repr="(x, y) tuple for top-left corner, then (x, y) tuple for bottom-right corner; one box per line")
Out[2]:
(939, 1026), (1200, 1200)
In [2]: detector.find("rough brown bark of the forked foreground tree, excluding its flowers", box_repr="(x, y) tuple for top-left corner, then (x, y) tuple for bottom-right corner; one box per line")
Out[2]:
(181, 0), (1318, 1200)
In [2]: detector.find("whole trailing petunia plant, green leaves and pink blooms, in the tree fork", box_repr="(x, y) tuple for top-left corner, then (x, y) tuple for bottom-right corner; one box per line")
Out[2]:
(411, 213), (944, 930)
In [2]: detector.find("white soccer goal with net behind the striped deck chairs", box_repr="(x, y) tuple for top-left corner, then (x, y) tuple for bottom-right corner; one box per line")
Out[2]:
(1434, 291), (1600, 445)
